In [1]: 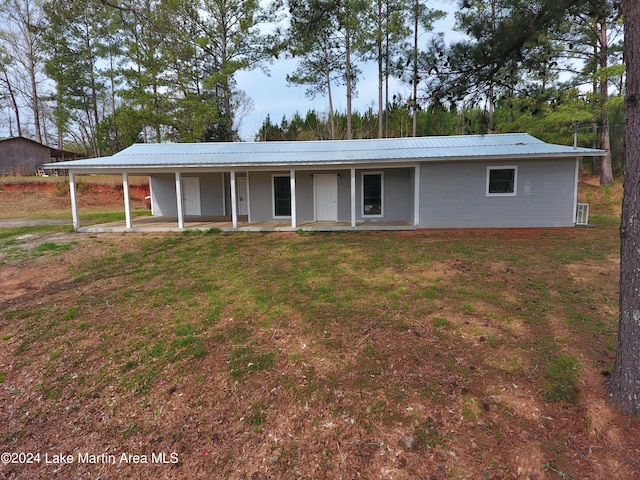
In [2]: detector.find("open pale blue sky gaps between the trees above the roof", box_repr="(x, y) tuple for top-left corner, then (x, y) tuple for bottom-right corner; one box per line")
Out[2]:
(236, 0), (457, 141)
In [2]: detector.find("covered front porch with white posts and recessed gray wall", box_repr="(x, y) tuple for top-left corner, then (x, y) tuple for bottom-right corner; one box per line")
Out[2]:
(69, 164), (420, 232)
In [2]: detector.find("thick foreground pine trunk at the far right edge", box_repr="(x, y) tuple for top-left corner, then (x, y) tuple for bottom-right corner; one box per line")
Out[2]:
(609, 0), (640, 415)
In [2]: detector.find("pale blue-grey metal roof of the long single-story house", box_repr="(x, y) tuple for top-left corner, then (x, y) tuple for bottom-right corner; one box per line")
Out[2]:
(45, 133), (606, 170)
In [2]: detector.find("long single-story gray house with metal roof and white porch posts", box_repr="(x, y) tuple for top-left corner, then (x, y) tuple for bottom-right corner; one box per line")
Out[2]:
(45, 133), (604, 231)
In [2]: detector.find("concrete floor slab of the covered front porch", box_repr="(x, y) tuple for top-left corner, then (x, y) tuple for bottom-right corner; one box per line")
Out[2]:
(77, 216), (417, 233)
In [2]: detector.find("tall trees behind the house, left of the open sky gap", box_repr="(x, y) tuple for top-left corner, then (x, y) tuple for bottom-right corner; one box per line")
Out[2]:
(0, 0), (281, 155)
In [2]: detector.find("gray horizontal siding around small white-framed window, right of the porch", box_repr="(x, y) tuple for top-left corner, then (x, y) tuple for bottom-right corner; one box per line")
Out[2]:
(419, 159), (577, 228)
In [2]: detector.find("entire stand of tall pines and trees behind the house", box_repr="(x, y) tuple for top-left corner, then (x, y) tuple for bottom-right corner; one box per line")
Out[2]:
(0, 0), (624, 169)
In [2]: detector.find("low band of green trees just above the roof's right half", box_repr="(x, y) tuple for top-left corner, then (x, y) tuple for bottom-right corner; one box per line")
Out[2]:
(255, 91), (624, 175)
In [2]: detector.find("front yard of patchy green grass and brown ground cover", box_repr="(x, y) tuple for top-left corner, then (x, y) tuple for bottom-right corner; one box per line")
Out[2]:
(0, 178), (640, 480)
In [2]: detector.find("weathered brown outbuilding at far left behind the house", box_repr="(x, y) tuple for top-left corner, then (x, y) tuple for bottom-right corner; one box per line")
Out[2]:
(0, 137), (80, 175)
